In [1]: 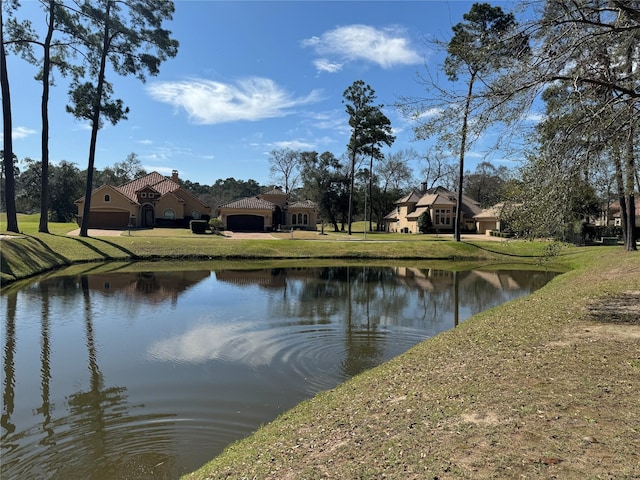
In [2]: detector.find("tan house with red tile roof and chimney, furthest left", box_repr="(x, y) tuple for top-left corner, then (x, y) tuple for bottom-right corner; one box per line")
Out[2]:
(75, 170), (211, 228)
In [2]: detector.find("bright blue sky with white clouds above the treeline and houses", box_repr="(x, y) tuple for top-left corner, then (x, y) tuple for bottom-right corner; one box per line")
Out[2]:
(8, 0), (524, 185)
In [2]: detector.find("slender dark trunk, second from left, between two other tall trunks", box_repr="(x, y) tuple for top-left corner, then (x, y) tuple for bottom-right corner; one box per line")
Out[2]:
(38, 0), (56, 233)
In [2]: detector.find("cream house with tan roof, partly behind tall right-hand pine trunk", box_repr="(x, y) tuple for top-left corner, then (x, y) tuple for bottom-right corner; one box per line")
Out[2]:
(383, 187), (482, 233)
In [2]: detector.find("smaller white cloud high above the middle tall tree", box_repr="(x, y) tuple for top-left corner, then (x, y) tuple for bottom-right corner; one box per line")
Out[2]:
(302, 25), (422, 73)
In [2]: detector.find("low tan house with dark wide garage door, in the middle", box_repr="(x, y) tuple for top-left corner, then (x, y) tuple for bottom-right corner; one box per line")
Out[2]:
(216, 188), (318, 232)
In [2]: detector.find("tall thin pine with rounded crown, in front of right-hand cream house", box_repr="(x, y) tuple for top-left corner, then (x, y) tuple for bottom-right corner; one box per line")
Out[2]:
(400, 3), (529, 241)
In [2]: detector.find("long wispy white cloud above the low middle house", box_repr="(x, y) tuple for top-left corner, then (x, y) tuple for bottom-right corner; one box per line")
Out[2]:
(147, 77), (320, 125)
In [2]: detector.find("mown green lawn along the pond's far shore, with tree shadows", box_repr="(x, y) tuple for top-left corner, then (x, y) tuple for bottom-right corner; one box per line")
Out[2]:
(0, 215), (573, 284)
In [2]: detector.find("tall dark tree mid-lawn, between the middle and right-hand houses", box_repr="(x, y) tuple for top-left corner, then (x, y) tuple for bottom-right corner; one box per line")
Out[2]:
(343, 80), (395, 235)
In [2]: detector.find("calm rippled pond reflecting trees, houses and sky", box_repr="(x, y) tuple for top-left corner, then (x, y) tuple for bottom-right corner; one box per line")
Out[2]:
(0, 265), (555, 480)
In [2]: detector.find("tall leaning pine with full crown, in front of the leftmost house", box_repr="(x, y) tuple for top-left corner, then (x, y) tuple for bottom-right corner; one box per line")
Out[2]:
(67, 0), (178, 237)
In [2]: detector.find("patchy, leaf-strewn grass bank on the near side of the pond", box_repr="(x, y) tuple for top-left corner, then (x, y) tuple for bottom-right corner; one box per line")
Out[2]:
(184, 249), (640, 480)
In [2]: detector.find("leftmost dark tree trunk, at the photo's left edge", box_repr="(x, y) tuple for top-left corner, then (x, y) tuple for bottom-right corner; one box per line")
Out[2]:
(0, 4), (19, 233)
